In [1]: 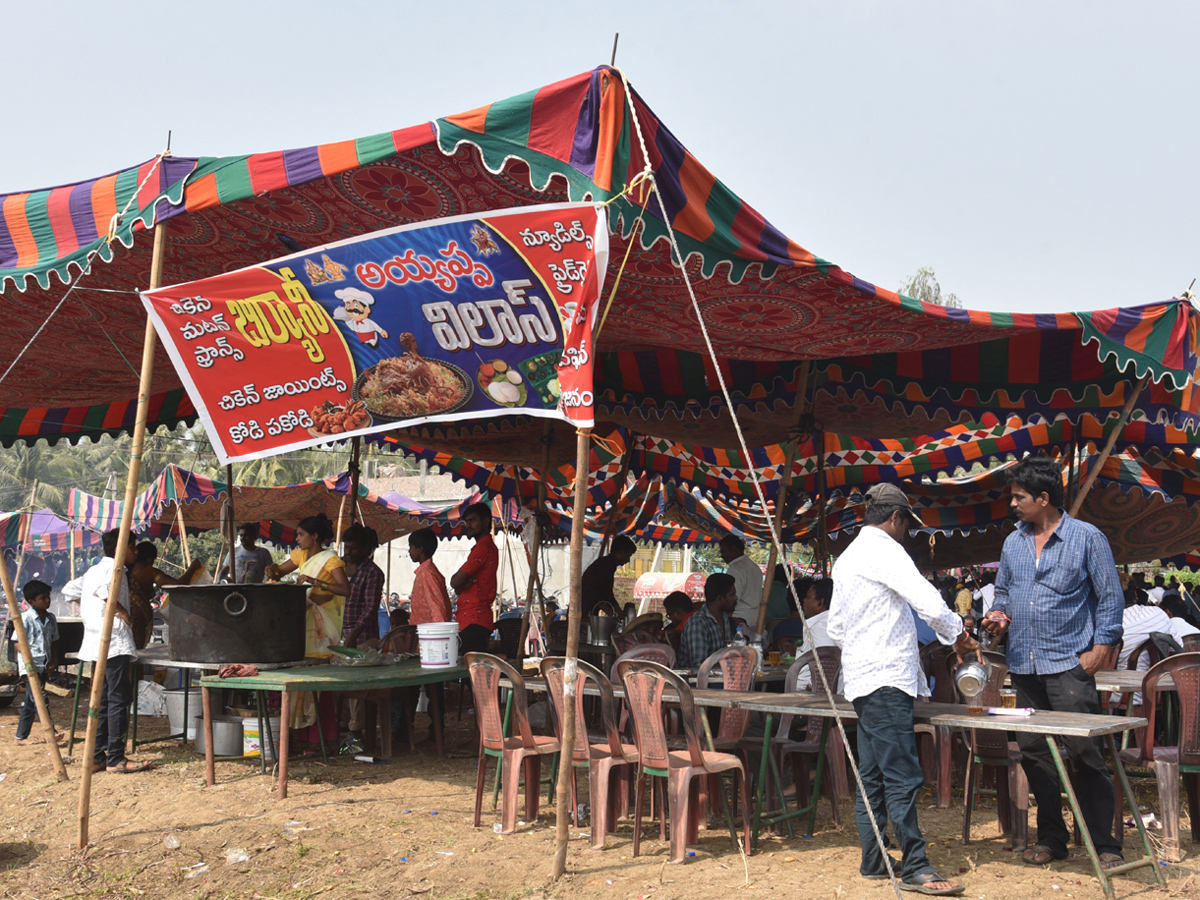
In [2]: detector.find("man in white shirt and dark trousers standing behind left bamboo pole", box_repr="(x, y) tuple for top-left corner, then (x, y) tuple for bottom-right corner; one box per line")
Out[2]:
(79, 528), (145, 773)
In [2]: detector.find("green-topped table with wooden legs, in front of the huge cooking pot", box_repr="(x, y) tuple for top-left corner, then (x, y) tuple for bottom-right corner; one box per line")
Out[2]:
(200, 659), (468, 800)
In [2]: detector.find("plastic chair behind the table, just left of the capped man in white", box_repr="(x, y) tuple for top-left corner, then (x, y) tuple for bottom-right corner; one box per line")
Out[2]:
(770, 647), (846, 828)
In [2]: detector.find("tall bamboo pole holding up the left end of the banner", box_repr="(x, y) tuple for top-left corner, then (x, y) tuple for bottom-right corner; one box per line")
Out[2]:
(79, 223), (167, 850)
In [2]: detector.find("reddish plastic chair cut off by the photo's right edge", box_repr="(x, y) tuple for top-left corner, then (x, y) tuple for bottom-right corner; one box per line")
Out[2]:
(1112, 653), (1200, 862)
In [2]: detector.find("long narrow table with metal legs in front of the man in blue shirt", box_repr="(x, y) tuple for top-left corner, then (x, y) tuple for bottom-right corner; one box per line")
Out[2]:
(526, 678), (1166, 900)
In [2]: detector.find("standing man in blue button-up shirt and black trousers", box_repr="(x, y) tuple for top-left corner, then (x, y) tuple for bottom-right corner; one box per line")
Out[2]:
(983, 456), (1124, 869)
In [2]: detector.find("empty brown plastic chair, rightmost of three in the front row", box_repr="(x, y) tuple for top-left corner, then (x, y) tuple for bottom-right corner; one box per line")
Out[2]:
(619, 660), (750, 863)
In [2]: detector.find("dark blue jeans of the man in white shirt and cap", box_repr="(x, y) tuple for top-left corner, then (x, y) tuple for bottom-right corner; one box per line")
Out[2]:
(854, 688), (934, 881)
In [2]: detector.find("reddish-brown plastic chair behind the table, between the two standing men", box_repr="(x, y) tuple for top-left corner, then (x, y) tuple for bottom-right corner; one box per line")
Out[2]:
(962, 652), (1030, 851)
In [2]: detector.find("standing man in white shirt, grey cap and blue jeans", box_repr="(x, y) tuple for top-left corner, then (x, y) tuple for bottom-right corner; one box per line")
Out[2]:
(828, 484), (979, 894)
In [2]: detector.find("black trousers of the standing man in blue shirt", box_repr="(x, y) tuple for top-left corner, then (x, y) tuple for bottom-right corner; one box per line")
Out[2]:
(1013, 666), (1121, 857)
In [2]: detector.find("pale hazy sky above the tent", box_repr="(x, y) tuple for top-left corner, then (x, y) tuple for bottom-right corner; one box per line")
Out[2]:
(0, 0), (1200, 311)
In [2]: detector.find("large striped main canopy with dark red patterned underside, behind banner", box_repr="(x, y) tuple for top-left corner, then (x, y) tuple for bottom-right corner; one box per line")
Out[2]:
(0, 67), (1198, 466)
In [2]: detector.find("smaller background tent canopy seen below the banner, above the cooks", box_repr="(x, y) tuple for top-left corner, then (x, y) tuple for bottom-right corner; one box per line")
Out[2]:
(67, 466), (442, 546)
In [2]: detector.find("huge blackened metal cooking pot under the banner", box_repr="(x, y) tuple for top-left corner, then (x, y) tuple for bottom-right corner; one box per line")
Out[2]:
(167, 584), (308, 662)
